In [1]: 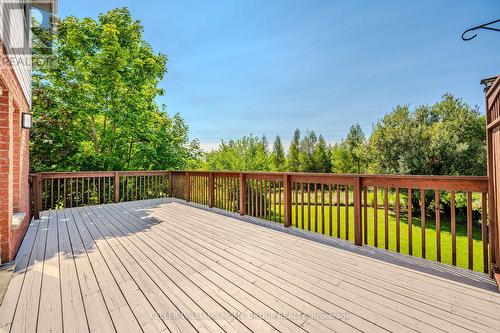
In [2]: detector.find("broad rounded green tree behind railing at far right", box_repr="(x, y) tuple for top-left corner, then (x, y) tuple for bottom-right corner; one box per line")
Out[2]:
(370, 94), (486, 175)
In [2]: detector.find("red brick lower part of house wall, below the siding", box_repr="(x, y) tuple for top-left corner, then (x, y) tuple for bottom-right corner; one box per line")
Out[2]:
(0, 41), (30, 263)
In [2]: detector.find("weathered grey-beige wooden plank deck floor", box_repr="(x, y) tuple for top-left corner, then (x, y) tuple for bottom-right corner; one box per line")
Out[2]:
(0, 199), (500, 332)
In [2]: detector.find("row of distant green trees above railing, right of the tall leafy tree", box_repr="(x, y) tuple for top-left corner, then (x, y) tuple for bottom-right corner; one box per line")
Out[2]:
(201, 94), (486, 175)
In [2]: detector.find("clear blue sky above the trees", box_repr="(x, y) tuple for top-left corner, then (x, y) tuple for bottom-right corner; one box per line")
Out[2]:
(59, 0), (500, 149)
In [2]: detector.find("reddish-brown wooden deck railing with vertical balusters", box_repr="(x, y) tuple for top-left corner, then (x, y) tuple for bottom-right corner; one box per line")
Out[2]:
(31, 171), (494, 272)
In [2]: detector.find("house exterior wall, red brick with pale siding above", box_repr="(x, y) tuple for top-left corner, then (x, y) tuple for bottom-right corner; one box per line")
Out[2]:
(0, 0), (31, 263)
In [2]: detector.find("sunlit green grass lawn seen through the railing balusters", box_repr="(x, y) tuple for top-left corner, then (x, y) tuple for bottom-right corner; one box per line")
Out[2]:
(262, 200), (483, 272)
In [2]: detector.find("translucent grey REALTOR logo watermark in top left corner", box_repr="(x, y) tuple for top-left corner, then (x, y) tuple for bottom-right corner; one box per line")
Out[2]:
(0, 0), (54, 66)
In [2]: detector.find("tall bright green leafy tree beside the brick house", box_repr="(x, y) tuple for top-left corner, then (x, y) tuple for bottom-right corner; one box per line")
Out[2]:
(31, 8), (199, 172)
